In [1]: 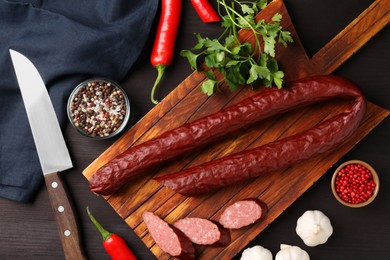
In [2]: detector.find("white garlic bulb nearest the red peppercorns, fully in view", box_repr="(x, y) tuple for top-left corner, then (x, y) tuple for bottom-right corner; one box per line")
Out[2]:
(295, 210), (333, 246)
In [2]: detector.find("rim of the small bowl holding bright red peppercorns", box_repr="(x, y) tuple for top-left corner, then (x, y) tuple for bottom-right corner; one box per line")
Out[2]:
(330, 160), (380, 208)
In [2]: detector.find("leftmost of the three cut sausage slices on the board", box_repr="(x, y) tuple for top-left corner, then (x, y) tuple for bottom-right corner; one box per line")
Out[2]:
(142, 211), (195, 259)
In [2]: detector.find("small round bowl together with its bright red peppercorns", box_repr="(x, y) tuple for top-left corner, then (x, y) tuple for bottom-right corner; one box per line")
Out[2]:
(331, 160), (379, 208)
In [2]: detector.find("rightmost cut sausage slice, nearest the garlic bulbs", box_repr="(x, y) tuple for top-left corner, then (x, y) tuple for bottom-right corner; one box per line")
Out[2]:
(219, 199), (268, 229)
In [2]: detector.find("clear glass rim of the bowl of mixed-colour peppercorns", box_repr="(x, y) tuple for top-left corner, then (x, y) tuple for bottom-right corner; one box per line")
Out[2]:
(66, 77), (131, 140)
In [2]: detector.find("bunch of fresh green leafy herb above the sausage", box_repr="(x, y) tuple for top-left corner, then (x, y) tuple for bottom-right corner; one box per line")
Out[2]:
(180, 0), (293, 96)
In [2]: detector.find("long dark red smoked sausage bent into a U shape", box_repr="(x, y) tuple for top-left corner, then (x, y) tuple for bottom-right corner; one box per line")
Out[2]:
(89, 76), (366, 195)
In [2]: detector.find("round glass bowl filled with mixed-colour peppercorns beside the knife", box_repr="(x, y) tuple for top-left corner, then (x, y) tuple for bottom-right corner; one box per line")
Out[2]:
(67, 78), (130, 139)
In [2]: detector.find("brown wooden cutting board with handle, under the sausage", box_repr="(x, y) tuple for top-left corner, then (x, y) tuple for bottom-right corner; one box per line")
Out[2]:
(83, 0), (390, 259)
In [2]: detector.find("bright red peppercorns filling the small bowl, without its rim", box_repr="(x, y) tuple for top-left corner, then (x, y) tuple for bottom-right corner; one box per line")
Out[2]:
(335, 163), (376, 204)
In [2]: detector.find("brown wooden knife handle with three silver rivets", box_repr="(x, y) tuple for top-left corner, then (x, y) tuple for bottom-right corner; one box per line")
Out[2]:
(44, 172), (87, 260)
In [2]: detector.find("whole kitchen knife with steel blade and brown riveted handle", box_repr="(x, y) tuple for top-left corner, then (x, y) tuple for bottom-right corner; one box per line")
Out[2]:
(9, 49), (86, 260)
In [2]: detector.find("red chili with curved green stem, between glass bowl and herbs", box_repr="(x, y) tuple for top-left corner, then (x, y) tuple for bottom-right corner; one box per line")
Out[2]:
(150, 0), (181, 104)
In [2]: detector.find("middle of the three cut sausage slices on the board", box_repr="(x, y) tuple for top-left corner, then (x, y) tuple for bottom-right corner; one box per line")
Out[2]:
(173, 217), (230, 246)
